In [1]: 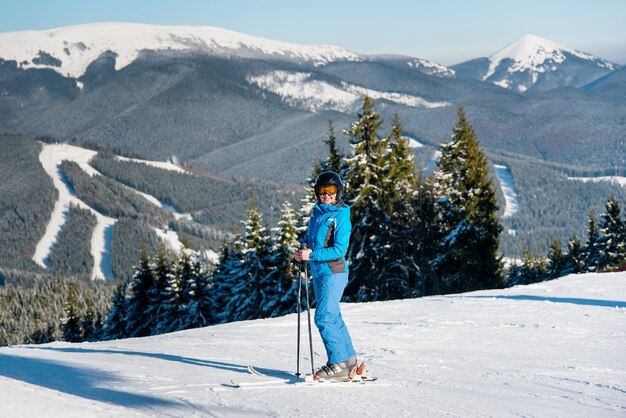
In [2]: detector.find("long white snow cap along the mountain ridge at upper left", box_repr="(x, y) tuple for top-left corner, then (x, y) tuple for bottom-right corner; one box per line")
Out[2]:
(0, 23), (361, 78)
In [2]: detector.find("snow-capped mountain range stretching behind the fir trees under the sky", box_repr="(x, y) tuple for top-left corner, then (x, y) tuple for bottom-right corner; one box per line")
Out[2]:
(0, 23), (626, 278)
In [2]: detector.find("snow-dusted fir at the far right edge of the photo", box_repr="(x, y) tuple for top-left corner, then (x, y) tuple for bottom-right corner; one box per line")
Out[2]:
(598, 195), (626, 269)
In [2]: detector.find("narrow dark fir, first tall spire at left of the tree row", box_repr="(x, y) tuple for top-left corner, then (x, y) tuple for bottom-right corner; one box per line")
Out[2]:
(126, 247), (155, 337)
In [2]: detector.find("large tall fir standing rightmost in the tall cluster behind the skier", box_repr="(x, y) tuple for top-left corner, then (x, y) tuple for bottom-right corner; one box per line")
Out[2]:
(435, 108), (504, 292)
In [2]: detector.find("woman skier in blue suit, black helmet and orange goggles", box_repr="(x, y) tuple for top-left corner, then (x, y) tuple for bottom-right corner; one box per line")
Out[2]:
(295, 171), (357, 381)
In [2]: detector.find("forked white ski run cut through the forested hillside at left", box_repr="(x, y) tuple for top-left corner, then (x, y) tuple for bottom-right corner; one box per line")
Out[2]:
(33, 144), (116, 279)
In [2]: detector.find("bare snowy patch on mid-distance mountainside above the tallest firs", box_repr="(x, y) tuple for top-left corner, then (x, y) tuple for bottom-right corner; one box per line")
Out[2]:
(248, 71), (450, 113)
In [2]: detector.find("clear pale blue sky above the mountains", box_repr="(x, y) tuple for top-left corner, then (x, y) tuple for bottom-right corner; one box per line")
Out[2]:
(0, 0), (626, 65)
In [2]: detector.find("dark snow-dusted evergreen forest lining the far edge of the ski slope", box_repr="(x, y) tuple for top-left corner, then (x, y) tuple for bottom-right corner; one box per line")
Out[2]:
(0, 96), (626, 345)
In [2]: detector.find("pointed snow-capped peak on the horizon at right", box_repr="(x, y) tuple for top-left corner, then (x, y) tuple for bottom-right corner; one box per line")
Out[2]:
(453, 35), (618, 92)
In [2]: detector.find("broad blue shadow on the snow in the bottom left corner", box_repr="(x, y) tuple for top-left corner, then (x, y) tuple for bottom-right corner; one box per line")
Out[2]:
(0, 353), (178, 409)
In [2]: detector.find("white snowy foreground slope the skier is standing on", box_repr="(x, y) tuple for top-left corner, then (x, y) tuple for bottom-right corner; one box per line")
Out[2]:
(0, 272), (626, 417)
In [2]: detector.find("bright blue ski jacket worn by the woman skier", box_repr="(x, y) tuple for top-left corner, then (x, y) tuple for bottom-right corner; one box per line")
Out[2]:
(304, 200), (352, 277)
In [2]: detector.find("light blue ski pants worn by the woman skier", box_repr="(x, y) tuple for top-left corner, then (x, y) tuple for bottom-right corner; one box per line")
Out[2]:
(313, 273), (356, 364)
